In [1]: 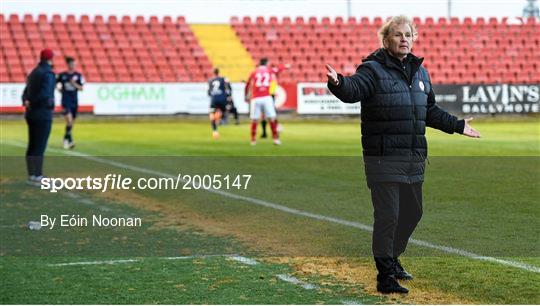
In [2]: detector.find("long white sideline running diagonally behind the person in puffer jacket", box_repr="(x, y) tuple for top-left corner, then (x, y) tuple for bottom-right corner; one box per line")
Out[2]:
(3, 141), (540, 273)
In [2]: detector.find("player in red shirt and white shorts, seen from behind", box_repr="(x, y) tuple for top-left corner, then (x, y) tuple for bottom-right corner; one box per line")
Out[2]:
(244, 58), (281, 145)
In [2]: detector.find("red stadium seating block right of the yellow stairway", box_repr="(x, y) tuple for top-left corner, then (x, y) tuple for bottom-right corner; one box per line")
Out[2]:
(231, 17), (540, 84)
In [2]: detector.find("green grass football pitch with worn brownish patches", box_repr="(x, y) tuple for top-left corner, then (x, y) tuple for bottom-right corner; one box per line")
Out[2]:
(0, 117), (540, 304)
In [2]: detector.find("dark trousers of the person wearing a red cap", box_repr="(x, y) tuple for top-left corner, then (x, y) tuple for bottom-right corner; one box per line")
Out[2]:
(26, 117), (52, 176)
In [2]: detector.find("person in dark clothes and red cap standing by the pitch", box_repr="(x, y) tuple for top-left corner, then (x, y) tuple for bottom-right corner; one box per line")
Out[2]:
(22, 49), (56, 186)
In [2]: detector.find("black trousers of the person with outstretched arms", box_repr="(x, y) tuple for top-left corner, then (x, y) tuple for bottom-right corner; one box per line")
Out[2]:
(370, 182), (422, 276)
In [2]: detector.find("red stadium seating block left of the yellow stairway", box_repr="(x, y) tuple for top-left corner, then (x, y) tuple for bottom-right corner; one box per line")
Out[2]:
(0, 15), (212, 82)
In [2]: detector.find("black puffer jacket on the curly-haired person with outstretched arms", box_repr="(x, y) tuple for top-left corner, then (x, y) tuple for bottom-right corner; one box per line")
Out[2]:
(328, 49), (464, 184)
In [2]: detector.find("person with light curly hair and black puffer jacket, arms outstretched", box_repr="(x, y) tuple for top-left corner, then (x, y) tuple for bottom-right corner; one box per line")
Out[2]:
(326, 16), (480, 293)
